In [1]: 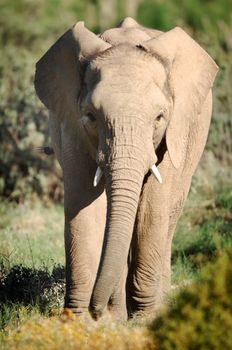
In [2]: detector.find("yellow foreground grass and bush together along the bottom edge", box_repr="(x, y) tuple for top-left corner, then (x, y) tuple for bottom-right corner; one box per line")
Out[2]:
(0, 248), (232, 350)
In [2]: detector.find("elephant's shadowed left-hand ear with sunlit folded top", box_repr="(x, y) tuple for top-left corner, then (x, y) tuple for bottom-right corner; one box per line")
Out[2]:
(34, 22), (110, 120)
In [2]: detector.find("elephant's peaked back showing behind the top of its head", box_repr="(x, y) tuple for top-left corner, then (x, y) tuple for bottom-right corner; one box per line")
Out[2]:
(100, 17), (162, 46)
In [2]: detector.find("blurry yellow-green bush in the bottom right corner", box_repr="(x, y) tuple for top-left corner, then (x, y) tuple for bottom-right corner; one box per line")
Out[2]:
(150, 249), (232, 350)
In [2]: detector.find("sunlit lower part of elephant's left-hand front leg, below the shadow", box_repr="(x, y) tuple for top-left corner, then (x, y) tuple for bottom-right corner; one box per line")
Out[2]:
(65, 208), (104, 315)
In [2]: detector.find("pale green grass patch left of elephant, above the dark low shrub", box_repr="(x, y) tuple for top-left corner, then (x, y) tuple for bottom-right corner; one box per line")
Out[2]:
(0, 202), (64, 269)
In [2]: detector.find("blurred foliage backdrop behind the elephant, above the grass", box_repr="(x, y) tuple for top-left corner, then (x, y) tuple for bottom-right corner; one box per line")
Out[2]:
(0, 0), (232, 202)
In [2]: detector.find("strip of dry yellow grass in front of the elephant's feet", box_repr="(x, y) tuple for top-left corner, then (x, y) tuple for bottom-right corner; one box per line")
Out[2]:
(2, 310), (153, 350)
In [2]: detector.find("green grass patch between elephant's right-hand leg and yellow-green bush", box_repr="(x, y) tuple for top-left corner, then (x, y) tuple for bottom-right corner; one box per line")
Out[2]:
(172, 187), (232, 284)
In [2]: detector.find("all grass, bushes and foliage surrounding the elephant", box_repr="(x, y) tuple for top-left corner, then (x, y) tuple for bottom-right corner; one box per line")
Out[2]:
(0, 0), (232, 350)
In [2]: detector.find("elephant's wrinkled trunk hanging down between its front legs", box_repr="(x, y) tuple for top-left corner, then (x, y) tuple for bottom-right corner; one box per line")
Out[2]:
(90, 142), (147, 319)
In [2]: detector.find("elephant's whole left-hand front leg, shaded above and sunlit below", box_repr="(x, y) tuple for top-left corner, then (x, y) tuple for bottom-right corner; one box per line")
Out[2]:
(61, 124), (106, 315)
